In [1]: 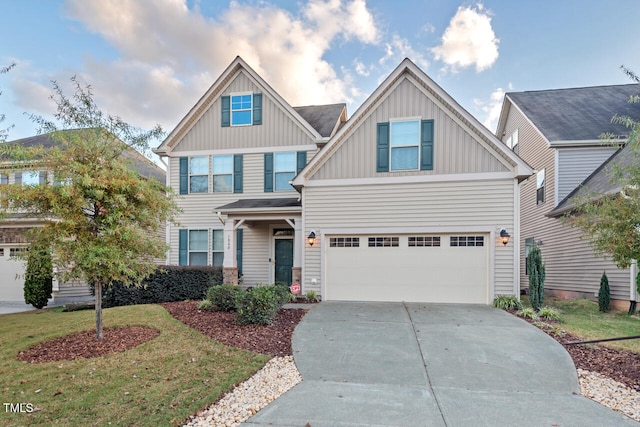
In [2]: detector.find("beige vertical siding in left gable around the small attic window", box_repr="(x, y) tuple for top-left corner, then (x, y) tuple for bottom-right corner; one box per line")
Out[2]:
(173, 72), (315, 152)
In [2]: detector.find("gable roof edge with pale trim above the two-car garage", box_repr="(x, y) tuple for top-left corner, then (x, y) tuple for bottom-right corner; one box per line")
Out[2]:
(293, 58), (533, 188)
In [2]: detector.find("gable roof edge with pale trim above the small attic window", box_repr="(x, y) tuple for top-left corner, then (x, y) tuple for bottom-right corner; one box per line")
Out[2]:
(153, 56), (339, 156)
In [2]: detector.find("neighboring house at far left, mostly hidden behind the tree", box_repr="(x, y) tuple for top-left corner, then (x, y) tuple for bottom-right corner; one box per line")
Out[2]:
(0, 134), (166, 303)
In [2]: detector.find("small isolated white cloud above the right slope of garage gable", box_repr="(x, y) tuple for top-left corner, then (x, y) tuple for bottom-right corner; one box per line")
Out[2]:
(431, 4), (500, 72)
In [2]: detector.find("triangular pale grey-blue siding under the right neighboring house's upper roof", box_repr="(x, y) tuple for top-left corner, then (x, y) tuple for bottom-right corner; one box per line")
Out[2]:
(555, 146), (617, 205)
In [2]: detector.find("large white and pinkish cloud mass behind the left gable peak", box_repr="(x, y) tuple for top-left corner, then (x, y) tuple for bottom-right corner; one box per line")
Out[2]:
(51, 0), (380, 130)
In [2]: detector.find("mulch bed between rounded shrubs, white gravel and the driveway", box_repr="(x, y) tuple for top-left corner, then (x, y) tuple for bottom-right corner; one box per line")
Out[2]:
(160, 301), (307, 356)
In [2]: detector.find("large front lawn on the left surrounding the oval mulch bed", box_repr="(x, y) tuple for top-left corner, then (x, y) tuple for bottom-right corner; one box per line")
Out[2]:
(0, 305), (269, 426)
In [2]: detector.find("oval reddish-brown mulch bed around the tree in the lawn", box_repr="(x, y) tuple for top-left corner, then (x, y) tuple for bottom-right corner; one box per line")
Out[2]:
(18, 326), (160, 363)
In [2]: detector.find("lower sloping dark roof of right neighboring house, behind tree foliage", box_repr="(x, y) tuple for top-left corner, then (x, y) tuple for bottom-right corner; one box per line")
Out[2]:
(547, 144), (638, 218)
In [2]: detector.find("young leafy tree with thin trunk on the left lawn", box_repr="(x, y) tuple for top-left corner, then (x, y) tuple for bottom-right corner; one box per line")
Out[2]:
(0, 77), (178, 338)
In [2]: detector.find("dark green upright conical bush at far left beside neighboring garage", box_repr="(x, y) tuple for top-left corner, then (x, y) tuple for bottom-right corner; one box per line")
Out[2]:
(24, 245), (53, 308)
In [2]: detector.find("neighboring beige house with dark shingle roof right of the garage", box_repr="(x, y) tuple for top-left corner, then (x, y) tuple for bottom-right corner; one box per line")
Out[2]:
(496, 84), (640, 308)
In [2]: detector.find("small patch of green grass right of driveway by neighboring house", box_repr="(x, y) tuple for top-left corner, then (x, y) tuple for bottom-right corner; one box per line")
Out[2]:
(522, 297), (640, 353)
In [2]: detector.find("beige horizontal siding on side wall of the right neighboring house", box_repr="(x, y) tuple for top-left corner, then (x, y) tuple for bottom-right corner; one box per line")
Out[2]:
(505, 108), (629, 300)
